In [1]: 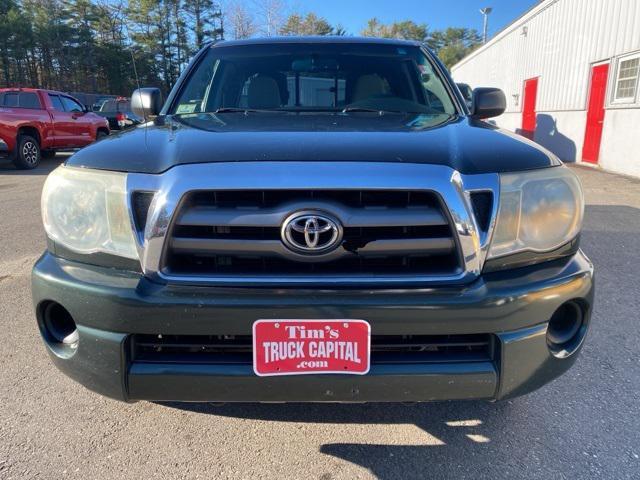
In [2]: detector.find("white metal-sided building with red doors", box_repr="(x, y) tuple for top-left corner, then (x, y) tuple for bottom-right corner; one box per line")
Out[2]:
(452, 0), (640, 176)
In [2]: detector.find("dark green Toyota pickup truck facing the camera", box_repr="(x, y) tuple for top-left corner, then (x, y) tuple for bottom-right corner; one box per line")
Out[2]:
(33, 38), (594, 402)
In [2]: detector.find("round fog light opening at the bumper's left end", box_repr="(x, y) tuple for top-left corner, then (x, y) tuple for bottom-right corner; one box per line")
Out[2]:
(38, 301), (80, 357)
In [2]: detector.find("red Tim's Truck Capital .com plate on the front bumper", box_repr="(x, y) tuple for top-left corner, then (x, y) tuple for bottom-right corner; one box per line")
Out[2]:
(253, 320), (371, 376)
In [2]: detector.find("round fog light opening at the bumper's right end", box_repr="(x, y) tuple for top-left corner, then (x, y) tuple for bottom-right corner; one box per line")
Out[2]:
(547, 300), (587, 358)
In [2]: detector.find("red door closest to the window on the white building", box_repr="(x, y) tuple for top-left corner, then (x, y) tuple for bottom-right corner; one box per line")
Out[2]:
(582, 63), (609, 163)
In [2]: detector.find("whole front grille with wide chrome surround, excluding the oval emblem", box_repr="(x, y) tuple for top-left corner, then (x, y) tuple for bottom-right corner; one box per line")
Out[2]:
(127, 161), (499, 288)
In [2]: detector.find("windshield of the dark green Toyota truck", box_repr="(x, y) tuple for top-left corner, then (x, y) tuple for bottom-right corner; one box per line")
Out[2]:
(172, 43), (456, 115)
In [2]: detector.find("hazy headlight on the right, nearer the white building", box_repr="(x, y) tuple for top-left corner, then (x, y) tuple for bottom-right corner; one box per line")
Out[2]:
(488, 167), (584, 258)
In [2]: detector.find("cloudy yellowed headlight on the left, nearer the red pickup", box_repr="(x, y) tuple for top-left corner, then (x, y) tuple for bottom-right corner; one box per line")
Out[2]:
(42, 166), (138, 259)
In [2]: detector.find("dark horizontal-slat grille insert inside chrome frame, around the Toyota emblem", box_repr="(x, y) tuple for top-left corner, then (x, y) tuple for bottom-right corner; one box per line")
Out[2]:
(163, 189), (462, 280)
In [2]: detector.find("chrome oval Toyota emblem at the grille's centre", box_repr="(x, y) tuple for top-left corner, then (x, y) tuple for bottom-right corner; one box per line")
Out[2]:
(281, 212), (342, 255)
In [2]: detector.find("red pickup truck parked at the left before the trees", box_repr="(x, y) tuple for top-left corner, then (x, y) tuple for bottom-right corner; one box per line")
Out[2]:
(0, 88), (109, 169)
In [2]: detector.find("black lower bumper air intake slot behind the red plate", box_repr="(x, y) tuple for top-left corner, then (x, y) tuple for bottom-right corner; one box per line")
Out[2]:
(132, 334), (493, 365)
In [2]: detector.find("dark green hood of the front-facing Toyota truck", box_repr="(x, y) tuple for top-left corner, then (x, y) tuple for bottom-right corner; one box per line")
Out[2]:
(67, 112), (560, 174)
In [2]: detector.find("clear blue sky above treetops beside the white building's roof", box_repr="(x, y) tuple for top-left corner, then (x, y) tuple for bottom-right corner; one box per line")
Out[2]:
(292, 0), (538, 35)
